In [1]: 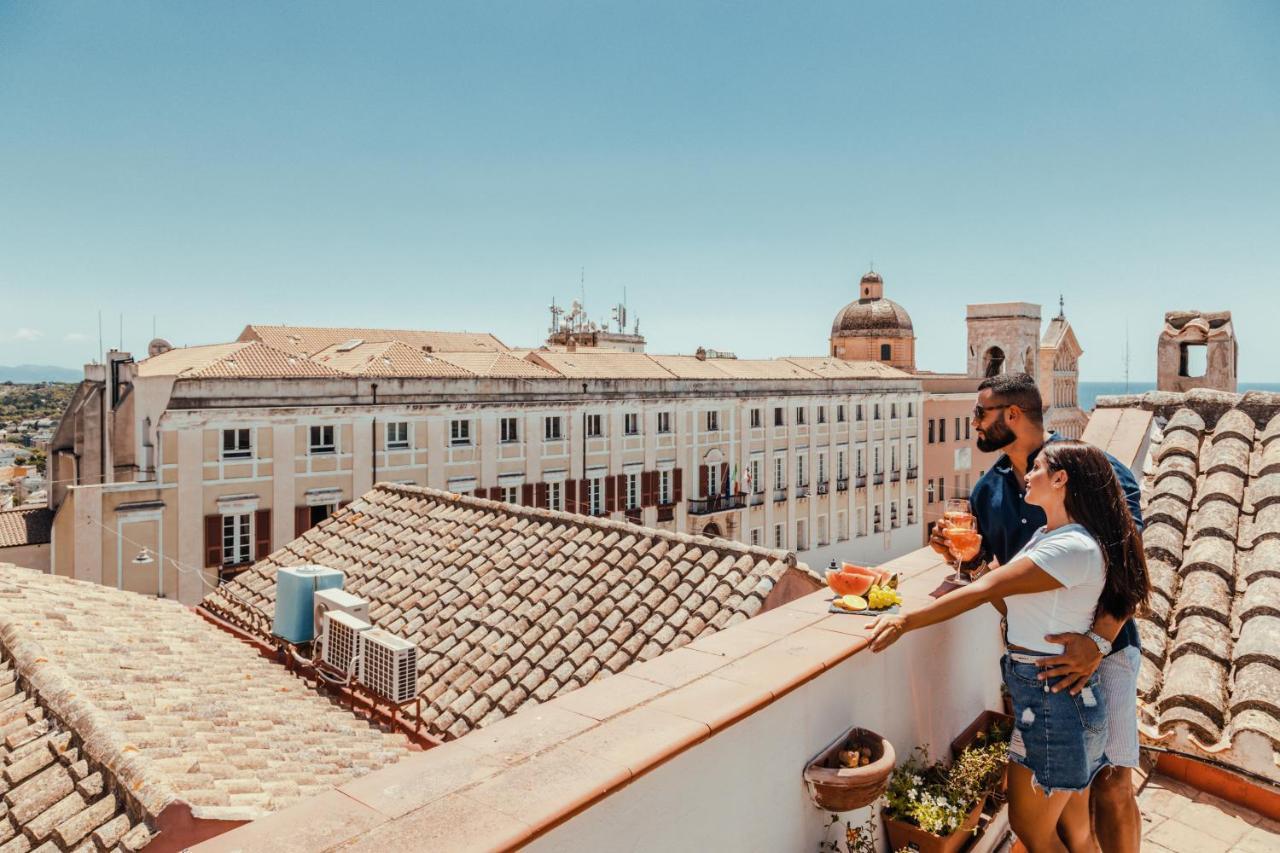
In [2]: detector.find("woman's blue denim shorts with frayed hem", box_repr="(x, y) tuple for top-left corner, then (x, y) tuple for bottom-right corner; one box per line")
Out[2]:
(1001, 652), (1107, 794)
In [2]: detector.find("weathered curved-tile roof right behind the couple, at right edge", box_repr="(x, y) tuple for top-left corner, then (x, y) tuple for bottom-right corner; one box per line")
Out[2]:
(1094, 391), (1280, 781)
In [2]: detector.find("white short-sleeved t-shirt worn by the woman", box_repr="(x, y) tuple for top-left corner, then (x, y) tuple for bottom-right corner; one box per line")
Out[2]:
(997, 524), (1106, 654)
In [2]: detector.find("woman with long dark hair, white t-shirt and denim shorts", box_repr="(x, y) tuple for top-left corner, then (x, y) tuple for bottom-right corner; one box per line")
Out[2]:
(869, 441), (1151, 853)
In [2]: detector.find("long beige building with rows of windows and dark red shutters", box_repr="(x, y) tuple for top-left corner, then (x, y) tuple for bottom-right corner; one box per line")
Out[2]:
(50, 327), (923, 602)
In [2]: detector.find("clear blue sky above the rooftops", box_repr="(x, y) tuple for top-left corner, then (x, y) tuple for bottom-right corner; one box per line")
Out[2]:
(0, 0), (1280, 382)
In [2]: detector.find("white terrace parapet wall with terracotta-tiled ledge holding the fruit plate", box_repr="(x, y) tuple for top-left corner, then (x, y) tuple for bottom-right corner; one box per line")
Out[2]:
(222, 549), (1008, 853)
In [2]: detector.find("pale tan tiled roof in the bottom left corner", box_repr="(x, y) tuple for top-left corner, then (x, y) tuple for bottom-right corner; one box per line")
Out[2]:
(0, 565), (411, 835)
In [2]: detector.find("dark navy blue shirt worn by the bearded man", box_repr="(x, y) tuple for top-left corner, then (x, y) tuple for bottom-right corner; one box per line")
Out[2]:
(969, 435), (1143, 653)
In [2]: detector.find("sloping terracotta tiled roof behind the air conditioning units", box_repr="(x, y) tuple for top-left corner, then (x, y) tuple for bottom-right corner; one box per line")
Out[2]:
(202, 484), (820, 739)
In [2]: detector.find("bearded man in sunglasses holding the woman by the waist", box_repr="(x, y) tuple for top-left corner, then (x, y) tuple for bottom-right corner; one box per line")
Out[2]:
(929, 373), (1143, 853)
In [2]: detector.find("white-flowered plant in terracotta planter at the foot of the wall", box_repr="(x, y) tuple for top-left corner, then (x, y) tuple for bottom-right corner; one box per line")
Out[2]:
(883, 747), (986, 853)
